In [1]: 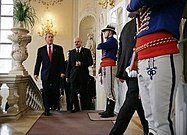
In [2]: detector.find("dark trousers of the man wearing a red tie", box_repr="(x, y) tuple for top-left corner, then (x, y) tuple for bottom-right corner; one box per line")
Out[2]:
(42, 79), (60, 112)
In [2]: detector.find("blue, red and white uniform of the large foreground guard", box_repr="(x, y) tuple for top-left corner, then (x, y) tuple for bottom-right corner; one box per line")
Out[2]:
(127, 0), (185, 135)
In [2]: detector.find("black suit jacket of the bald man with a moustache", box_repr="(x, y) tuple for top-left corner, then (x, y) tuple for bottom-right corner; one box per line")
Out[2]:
(66, 47), (93, 83)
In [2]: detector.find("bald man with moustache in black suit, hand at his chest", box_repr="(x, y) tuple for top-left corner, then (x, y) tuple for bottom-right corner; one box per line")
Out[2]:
(66, 37), (93, 112)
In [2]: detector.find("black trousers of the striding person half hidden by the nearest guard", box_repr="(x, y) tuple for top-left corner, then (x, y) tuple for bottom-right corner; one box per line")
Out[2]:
(110, 78), (148, 135)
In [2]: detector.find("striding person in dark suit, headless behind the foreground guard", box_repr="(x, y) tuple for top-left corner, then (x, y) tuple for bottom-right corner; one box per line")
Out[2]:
(110, 19), (149, 135)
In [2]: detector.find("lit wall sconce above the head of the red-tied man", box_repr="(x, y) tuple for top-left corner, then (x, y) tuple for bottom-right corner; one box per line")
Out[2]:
(38, 19), (57, 37)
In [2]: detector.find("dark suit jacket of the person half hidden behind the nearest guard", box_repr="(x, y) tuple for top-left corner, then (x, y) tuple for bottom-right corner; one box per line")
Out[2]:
(116, 19), (136, 79)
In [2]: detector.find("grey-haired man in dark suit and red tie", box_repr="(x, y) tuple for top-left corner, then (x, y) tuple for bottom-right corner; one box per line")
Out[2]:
(34, 33), (65, 116)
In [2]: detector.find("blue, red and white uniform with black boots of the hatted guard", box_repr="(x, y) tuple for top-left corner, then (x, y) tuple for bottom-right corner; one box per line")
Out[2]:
(97, 36), (118, 117)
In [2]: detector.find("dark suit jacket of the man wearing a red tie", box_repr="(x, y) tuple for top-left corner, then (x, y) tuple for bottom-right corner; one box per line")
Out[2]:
(34, 44), (65, 81)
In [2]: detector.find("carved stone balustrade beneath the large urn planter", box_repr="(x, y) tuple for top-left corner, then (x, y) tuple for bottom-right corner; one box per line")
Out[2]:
(0, 75), (43, 119)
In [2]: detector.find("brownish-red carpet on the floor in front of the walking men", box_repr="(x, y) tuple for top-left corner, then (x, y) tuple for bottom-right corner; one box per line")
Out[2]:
(27, 111), (113, 135)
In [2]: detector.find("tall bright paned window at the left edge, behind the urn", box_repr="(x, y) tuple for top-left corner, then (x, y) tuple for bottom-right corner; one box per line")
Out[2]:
(0, 0), (13, 73)
